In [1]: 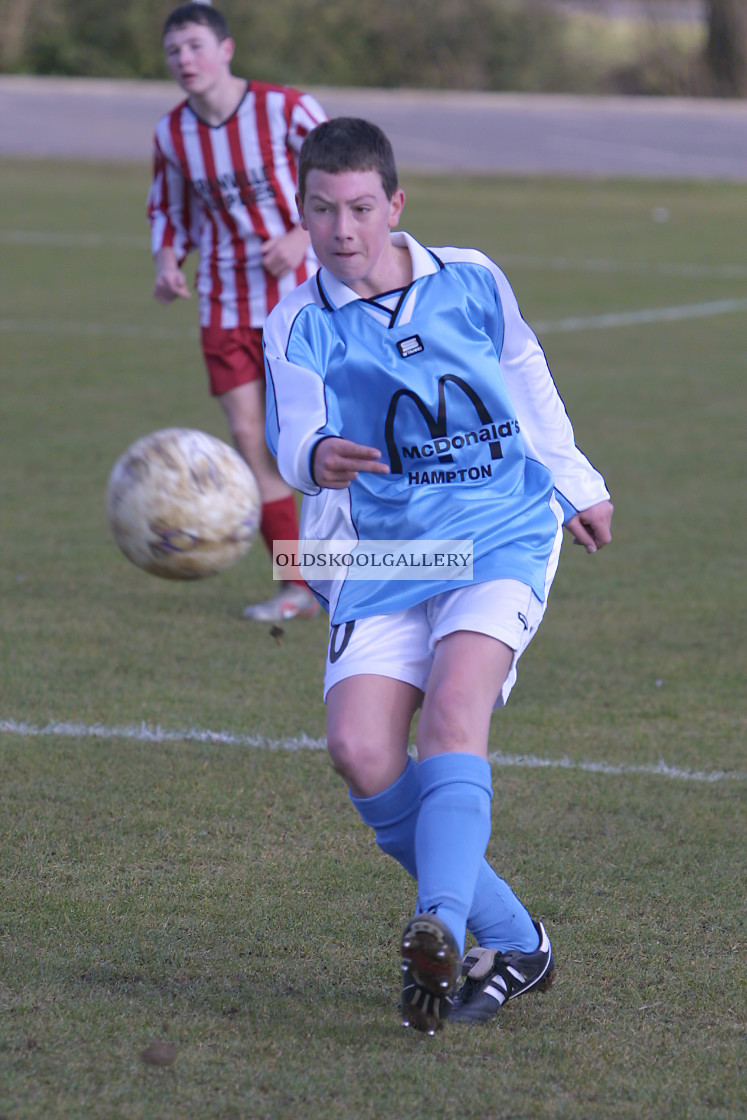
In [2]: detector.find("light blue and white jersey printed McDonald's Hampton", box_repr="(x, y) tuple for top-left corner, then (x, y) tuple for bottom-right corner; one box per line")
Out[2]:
(264, 234), (608, 624)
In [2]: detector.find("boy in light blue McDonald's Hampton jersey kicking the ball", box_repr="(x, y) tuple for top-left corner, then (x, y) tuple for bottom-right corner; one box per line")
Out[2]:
(264, 118), (613, 1034)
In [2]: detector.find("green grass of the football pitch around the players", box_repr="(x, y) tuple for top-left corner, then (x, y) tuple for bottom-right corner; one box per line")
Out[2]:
(0, 161), (747, 1120)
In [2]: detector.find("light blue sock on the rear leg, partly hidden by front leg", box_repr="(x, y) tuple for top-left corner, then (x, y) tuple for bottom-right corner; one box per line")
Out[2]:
(351, 758), (538, 953)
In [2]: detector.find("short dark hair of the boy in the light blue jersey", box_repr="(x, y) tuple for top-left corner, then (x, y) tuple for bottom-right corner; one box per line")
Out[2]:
(298, 116), (399, 200)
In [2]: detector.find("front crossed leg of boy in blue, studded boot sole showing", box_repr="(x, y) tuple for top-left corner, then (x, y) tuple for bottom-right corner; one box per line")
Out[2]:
(402, 632), (513, 1034)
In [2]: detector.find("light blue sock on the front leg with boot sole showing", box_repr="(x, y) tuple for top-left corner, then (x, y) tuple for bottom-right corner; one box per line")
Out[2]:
(415, 754), (493, 951)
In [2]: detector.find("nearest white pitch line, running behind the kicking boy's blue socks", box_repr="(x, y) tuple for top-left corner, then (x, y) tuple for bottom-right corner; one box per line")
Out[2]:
(0, 719), (747, 784)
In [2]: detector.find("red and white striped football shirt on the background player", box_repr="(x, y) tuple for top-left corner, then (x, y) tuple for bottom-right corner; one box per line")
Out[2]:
(148, 82), (326, 328)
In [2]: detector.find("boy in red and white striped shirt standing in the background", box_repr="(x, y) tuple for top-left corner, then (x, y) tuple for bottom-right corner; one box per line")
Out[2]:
(148, 3), (326, 622)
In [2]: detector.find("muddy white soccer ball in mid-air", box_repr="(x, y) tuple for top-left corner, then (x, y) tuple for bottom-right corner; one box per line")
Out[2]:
(106, 428), (260, 579)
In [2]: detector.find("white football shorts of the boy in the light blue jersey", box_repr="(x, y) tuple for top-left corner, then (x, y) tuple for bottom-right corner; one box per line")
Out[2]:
(324, 568), (559, 708)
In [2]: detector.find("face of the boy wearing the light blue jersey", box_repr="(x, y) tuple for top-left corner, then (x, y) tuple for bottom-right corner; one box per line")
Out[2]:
(298, 168), (404, 298)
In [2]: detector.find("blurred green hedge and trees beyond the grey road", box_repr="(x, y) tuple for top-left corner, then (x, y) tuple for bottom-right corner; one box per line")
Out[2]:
(0, 0), (747, 97)
